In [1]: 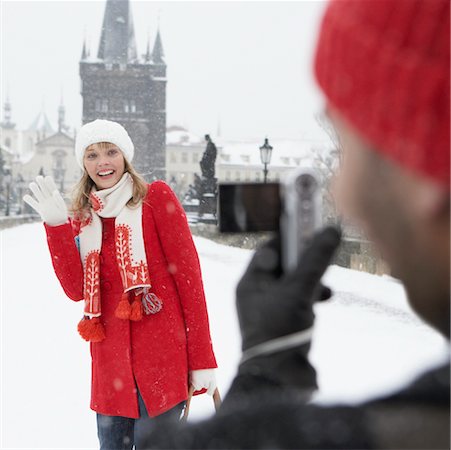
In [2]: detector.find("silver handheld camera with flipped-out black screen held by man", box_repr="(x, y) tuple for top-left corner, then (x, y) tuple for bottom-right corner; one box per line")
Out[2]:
(218, 168), (322, 271)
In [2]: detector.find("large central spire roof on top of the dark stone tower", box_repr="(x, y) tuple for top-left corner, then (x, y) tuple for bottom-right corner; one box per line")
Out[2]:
(97, 0), (137, 64)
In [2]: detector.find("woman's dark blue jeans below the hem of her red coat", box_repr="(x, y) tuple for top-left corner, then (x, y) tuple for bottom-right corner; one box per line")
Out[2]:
(97, 392), (185, 450)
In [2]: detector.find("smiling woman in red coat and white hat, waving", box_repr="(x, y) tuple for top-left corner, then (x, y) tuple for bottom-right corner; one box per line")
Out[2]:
(24, 120), (217, 450)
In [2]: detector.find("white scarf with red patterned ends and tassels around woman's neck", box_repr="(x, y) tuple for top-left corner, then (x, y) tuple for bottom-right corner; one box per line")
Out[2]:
(79, 172), (162, 340)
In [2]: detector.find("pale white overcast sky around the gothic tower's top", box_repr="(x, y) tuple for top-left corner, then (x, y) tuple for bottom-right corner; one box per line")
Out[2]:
(1, 0), (324, 139)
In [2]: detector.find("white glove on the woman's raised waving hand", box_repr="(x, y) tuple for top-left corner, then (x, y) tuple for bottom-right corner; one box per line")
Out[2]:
(23, 176), (68, 227)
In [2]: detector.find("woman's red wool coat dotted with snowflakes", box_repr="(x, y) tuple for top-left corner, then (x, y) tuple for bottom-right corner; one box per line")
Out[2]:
(45, 181), (217, 418)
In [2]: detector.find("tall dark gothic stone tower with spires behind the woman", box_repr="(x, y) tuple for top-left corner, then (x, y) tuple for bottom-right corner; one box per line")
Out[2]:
(80, 0), (166, 181)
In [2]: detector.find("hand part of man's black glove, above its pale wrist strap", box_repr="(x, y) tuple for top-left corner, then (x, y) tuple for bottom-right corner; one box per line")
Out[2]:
(237, 227), (340, 351)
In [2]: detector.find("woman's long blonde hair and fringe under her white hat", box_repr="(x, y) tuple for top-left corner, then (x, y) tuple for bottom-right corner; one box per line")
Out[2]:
(70, 142), (147, 220)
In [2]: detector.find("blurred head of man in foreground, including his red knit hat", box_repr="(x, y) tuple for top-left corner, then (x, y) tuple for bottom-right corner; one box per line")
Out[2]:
(315, 0), (450, 335)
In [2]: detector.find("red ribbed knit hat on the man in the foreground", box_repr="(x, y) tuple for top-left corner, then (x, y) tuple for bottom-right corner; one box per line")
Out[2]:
(315, 0), (450, 188)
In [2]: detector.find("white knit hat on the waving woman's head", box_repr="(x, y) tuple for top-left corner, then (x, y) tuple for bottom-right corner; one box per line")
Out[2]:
(75, 119), (135, 169)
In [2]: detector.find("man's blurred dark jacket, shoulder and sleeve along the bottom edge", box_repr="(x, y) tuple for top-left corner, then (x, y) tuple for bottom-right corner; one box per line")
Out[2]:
(138, 365), (450, 450)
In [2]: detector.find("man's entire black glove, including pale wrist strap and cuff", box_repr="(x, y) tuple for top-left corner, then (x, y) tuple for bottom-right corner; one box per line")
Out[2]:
(232, 227), (340, 394)
